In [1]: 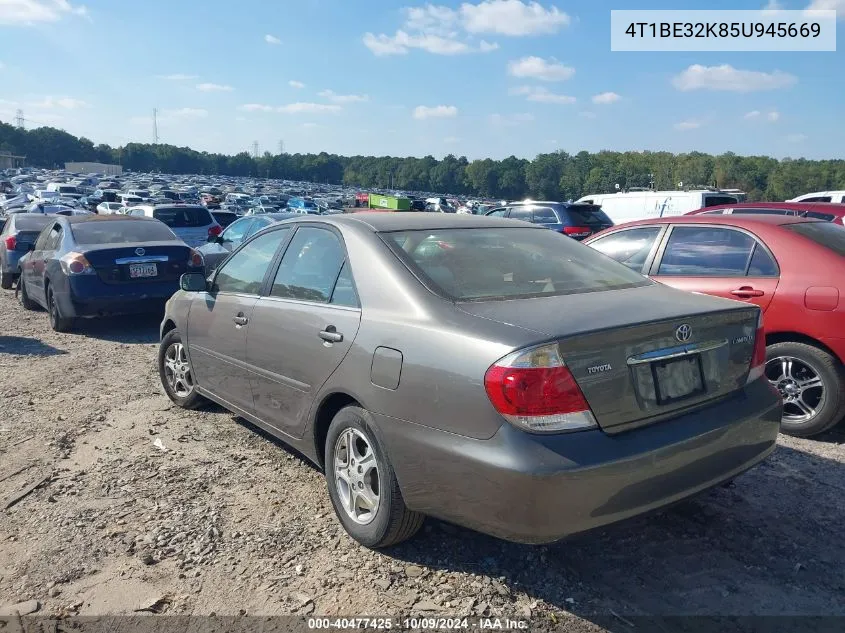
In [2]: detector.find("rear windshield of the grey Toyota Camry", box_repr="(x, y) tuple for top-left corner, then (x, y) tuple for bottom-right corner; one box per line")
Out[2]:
(382, 228), (652, 301)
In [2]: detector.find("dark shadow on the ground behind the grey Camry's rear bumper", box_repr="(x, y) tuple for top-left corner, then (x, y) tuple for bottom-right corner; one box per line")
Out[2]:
(378, 447), (845, 632)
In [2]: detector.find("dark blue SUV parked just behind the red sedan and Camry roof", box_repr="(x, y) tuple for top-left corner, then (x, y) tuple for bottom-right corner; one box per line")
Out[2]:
(485, 200), (613, 240)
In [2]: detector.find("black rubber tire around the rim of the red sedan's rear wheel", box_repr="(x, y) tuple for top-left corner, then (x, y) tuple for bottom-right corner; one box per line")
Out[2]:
(766, 341), (845, 437)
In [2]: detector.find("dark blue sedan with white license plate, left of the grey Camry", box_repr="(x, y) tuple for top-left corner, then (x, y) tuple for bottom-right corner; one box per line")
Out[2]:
(19, 215), (202, 332)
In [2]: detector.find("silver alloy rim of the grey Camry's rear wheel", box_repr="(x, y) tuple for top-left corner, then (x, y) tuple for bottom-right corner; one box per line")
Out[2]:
(334, 427), (380, 525)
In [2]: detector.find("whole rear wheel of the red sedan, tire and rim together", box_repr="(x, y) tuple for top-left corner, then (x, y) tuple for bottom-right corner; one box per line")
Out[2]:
(766, 341), (845, 437)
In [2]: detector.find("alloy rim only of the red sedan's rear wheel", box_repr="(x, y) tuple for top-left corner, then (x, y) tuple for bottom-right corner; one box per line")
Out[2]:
(766, 356), (826, 424)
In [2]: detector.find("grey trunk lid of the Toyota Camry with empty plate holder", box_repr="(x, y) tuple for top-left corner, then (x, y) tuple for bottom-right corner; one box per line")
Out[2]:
(459, 284), (758, 433)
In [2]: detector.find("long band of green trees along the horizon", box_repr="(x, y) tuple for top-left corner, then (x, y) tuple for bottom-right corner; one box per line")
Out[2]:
(0, 123), (845, 200)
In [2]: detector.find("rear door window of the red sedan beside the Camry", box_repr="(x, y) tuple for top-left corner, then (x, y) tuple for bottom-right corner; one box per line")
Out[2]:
(657, 226), (757, 277)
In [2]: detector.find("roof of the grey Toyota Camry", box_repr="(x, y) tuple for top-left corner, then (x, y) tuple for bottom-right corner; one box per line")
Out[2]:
(295, 211), (547, 232)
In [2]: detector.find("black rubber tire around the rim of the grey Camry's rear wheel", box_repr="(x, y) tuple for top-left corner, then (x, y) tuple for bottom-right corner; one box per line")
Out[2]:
(323, 406), (425, 549)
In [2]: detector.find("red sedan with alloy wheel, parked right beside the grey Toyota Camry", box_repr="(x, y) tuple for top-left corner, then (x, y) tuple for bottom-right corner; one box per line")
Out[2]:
(584, 214), (845, 437)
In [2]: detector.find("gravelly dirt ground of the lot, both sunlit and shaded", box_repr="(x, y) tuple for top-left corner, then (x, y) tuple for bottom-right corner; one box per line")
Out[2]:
(0, 292), (845, 631)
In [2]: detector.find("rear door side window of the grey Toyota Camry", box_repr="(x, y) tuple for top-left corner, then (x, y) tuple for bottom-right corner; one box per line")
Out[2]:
(270, 226), (346, 303)
